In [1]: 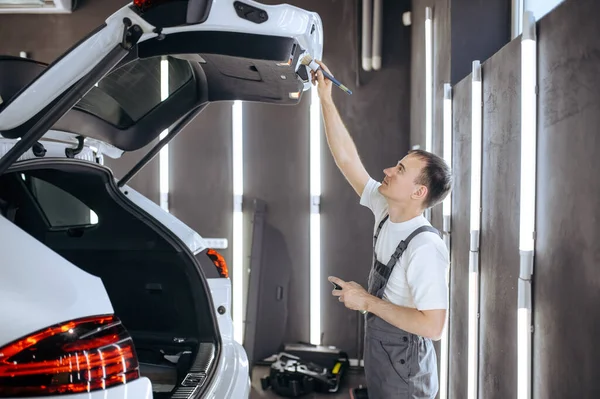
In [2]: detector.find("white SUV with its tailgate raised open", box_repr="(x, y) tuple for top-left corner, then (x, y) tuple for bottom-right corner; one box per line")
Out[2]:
(0, 0), (323, 399)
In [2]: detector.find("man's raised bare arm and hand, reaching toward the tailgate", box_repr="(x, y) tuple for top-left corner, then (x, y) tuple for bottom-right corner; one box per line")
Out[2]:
(313, 61), (369, 196)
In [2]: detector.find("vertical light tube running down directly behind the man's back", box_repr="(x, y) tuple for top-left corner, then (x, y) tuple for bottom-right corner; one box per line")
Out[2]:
(440, 83), (452, 399)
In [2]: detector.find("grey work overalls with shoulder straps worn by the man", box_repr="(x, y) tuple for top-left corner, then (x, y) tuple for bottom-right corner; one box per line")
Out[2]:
(364, 215), (439, 399)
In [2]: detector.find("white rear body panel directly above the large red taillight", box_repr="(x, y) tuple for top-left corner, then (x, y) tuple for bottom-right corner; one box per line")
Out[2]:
(0, 216), (113, 347)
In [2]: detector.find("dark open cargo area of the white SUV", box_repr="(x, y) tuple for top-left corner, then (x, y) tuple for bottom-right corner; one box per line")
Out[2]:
(0, 160), (221, 398)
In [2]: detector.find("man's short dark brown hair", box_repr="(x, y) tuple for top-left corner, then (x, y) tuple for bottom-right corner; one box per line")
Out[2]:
(408, 150), (452, 208)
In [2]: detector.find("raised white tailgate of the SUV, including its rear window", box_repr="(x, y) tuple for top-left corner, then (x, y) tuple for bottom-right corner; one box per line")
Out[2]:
(0, 0), (323, 159)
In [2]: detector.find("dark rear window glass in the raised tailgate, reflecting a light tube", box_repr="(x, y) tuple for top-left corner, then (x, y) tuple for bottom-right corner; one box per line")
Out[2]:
(75, 57), (192, 129)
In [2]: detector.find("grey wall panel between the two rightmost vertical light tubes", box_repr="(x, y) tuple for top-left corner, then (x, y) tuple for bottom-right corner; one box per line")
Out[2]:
(479, 40), (521, 399)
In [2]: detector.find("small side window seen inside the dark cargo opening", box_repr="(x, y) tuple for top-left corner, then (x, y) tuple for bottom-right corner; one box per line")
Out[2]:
(22, 175), (98, 228)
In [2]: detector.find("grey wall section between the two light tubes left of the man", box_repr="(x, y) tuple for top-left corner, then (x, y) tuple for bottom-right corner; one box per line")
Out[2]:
(244, 93), (312, 344)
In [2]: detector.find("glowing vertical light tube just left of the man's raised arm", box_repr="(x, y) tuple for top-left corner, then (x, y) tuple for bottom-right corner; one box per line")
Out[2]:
(309, 87), (321, 345)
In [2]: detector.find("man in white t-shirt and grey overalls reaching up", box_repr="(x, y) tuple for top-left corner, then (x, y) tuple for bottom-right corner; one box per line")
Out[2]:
(312, 62), (452, 399)
